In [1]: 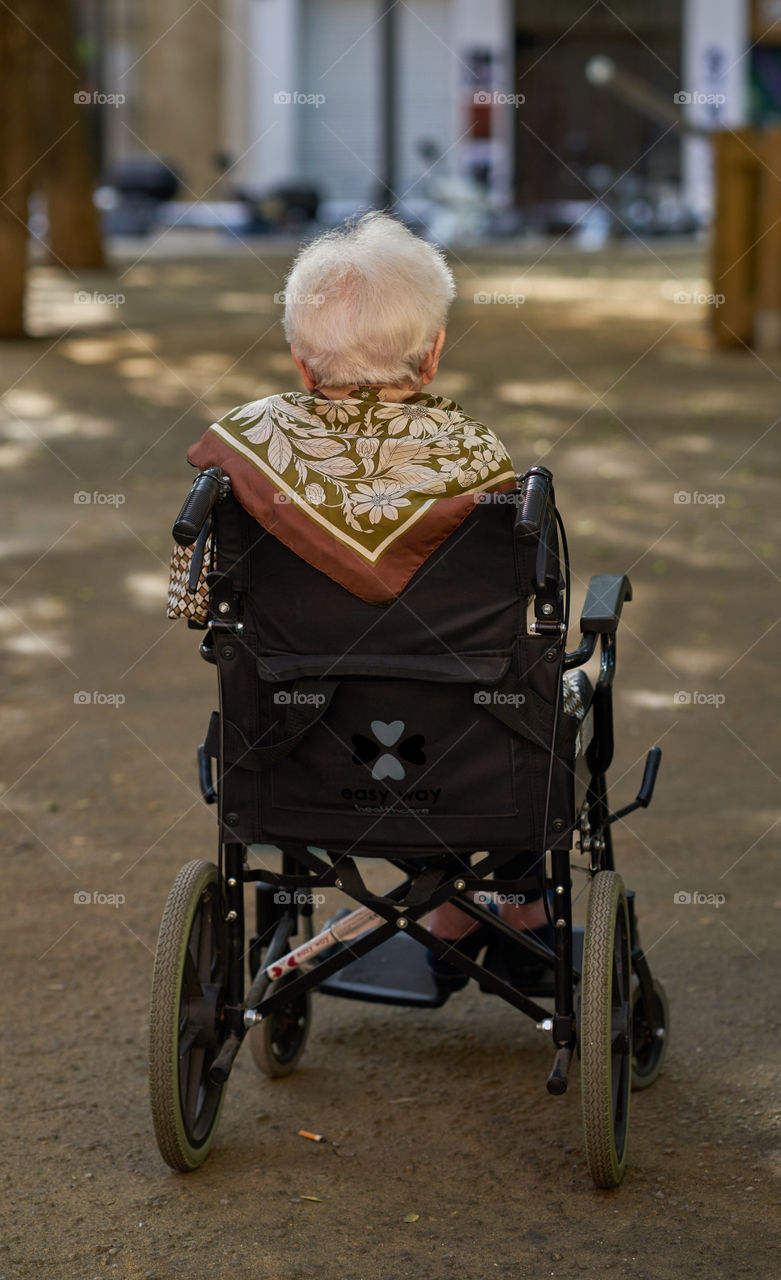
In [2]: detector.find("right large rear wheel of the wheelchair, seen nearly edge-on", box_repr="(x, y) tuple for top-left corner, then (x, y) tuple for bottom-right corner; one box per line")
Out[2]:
(580, 872), (632, 1188)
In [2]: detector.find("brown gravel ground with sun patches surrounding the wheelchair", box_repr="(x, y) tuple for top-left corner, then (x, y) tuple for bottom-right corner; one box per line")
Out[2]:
(0, 242), (781, 1280)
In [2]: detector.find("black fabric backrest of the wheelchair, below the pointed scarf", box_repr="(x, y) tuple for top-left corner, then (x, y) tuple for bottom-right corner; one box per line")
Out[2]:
(207, 495), (577, 856)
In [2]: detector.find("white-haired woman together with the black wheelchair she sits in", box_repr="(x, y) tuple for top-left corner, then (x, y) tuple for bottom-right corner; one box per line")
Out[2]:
(150, 214), (668, 1187)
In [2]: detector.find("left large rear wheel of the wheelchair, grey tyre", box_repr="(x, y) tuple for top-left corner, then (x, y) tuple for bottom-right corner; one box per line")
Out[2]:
(149, 861), (227, 1172)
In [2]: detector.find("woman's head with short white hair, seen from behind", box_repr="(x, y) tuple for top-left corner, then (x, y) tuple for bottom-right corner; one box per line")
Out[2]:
(283, 212), (456, 387)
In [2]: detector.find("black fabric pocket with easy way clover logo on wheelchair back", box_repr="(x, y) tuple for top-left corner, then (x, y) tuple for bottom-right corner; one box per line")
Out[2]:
(212, 654), (563, 854)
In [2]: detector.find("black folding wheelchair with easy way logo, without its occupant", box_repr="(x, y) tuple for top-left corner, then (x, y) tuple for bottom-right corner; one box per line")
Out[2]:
(150, 467), (668, 1188)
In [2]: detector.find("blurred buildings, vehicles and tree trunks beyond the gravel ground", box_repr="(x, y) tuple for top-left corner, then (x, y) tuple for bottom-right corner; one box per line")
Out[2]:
(7, 0), (781, 348)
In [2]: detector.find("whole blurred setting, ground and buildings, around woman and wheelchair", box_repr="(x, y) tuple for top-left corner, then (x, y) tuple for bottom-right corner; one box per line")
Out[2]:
(0, 0), (781, 1280)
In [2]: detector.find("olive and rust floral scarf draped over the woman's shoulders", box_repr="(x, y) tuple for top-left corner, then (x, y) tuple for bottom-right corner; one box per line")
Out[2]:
(187, 387), (515, 604)
